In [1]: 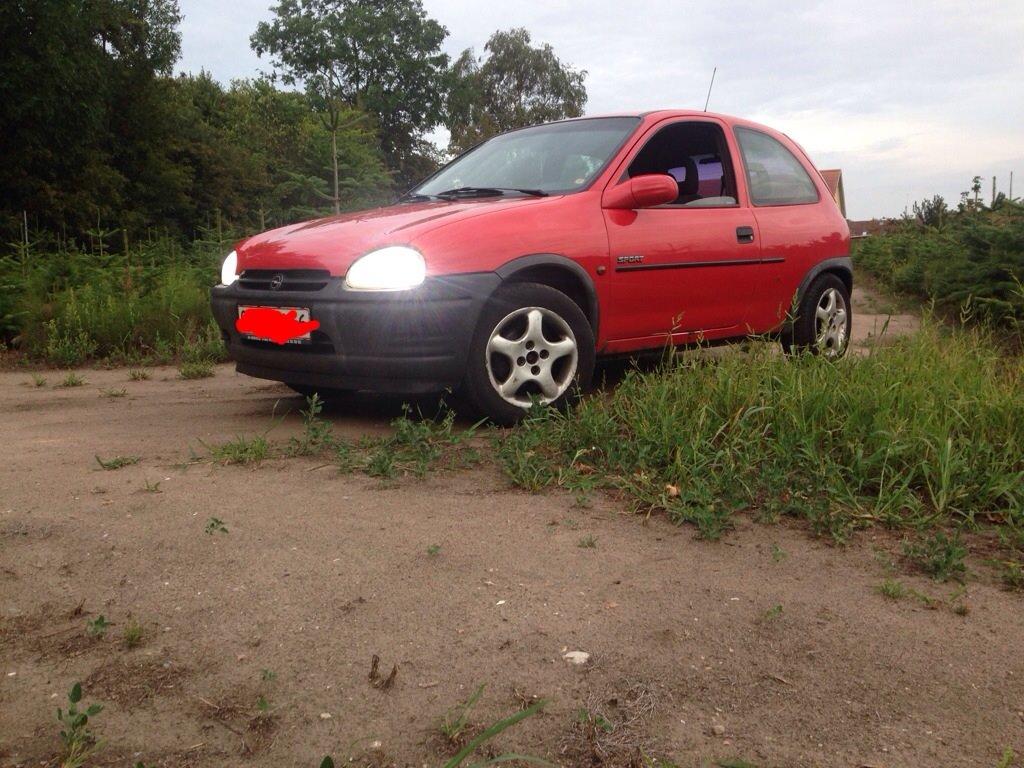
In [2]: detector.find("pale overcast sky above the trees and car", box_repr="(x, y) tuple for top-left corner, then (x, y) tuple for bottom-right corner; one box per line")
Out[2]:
(178, 0), (1024, 219)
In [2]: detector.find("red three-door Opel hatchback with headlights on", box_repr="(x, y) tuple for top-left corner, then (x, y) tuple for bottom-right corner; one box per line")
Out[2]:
(212, 111), (853, 422)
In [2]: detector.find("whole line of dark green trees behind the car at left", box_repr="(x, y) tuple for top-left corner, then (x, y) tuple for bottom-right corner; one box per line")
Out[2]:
(0, 0), (587, 243)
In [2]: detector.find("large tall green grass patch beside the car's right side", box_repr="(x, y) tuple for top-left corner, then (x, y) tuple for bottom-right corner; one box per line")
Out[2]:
(495, 322), (1024, 542)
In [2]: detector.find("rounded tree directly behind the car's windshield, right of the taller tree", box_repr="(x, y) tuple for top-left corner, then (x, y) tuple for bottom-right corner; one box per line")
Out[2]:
(445, 29), (587, 153)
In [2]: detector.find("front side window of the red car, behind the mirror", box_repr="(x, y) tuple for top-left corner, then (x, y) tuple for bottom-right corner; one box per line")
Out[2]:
(626, 123), (736, 208)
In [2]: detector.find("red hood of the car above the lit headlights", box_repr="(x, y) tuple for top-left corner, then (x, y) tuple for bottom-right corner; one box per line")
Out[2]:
(236, 198), (554, 276)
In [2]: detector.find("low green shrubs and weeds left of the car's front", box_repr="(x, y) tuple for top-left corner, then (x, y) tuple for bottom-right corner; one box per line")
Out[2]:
(0, 240), (228, 367)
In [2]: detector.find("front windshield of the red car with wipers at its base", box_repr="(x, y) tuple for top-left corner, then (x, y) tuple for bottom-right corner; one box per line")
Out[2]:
(408, 118), (639, 197)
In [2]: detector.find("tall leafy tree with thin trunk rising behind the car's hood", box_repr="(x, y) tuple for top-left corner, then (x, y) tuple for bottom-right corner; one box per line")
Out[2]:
(251, 0), (449, 211)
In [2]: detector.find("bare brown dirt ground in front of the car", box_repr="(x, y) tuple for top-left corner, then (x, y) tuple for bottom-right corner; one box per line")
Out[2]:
(0, 290), (1024, 768)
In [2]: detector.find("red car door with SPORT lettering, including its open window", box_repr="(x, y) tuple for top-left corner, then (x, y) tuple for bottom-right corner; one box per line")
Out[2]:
(604, 118), (761, 351)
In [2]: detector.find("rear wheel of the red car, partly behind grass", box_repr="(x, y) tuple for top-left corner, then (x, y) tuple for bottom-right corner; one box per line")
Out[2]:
(781, 272), (853, 359)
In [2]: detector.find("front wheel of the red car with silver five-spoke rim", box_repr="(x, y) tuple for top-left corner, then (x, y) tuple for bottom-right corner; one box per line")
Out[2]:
(463, 283), (595, 424)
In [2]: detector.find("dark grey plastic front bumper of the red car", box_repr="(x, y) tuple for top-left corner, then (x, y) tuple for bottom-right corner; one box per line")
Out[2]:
(210, 272), (501, 394)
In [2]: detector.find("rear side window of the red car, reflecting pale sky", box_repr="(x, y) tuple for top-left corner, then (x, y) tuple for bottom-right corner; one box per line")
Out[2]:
(736, 128), (818, 206)
